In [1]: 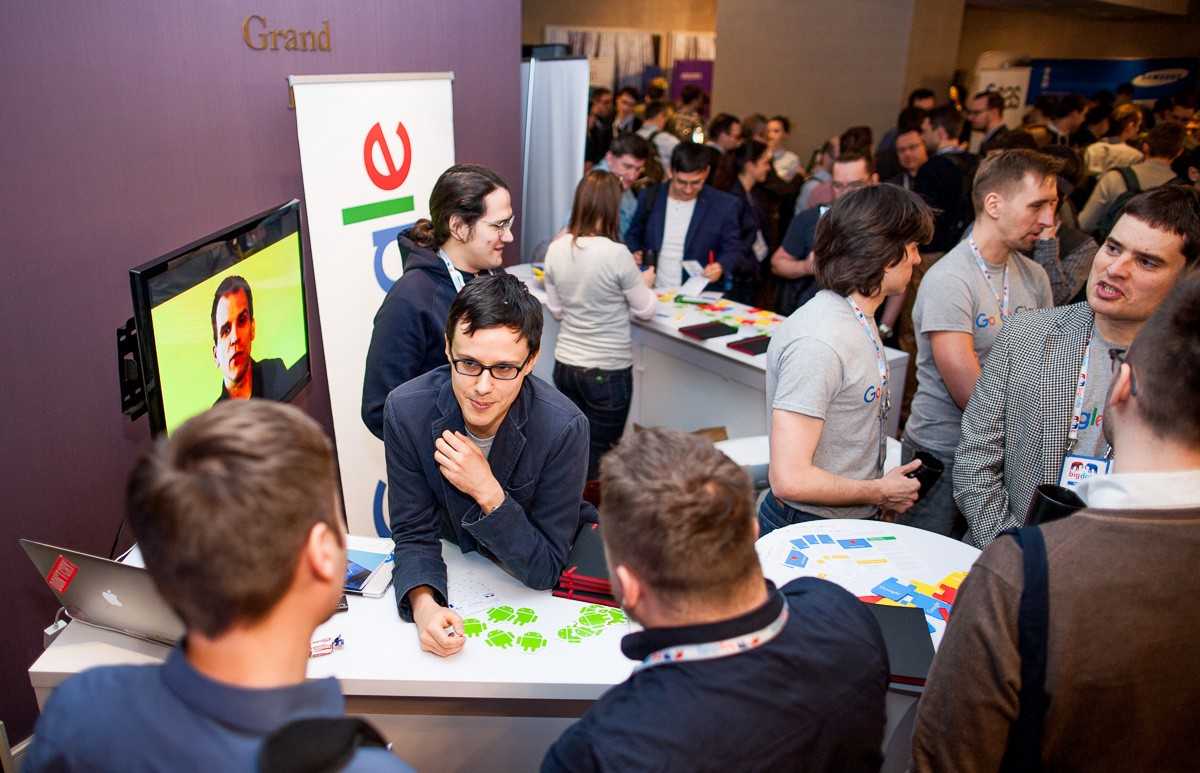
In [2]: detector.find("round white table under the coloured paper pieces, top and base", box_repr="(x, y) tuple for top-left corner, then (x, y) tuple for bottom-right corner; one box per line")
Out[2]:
(755, 519), (979, 761)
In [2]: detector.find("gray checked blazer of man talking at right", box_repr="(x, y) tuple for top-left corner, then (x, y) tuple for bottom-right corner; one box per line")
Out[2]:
(954, 302), (1093, 547)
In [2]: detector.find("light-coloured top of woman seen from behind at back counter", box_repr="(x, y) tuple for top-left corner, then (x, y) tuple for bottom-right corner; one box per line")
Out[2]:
(546, 234), (642, 371)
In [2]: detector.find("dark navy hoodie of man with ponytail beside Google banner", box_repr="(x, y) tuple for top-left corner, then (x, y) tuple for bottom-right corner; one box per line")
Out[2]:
(362, 234), (487, 439)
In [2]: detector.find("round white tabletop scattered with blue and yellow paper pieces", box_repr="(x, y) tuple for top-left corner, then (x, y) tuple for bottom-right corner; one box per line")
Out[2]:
(755, 519), (979, 649)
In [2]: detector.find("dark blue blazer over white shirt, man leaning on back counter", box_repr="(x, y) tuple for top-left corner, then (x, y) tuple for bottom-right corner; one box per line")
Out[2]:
(625, 182), (744, 277)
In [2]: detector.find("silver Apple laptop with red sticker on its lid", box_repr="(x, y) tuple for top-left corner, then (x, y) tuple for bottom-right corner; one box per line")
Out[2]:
(19, 539), (184, 647)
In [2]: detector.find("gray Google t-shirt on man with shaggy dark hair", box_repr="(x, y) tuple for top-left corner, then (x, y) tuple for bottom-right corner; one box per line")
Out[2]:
(767, 290), (883, 519)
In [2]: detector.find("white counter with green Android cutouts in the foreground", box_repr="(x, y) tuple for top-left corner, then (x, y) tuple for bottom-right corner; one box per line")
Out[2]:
(29, 537), (634, 772)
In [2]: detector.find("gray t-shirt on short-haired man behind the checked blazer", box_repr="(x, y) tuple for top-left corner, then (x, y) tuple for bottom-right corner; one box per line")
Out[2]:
(905, 239), (1054, 460)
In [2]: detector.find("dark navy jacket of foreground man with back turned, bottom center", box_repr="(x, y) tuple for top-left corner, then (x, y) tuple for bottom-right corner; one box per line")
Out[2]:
(541, 577), (888, 773)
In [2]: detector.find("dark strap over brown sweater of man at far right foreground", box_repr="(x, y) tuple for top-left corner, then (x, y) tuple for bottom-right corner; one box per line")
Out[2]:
(1001, 526), (1050, 773)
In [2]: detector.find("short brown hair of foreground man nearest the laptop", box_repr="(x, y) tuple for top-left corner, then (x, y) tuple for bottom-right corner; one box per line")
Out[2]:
(126, 400), (342, 637)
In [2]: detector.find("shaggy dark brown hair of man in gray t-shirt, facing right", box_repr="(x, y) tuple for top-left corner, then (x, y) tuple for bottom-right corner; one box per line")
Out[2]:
(812, 185), (934, 295)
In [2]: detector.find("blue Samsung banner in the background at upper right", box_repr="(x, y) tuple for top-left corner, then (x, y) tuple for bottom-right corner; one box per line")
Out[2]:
(1025, 58), (1200, 104)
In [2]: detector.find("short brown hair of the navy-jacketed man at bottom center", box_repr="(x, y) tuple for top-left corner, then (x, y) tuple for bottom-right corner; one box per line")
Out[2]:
(600, 429), (758, 603)
